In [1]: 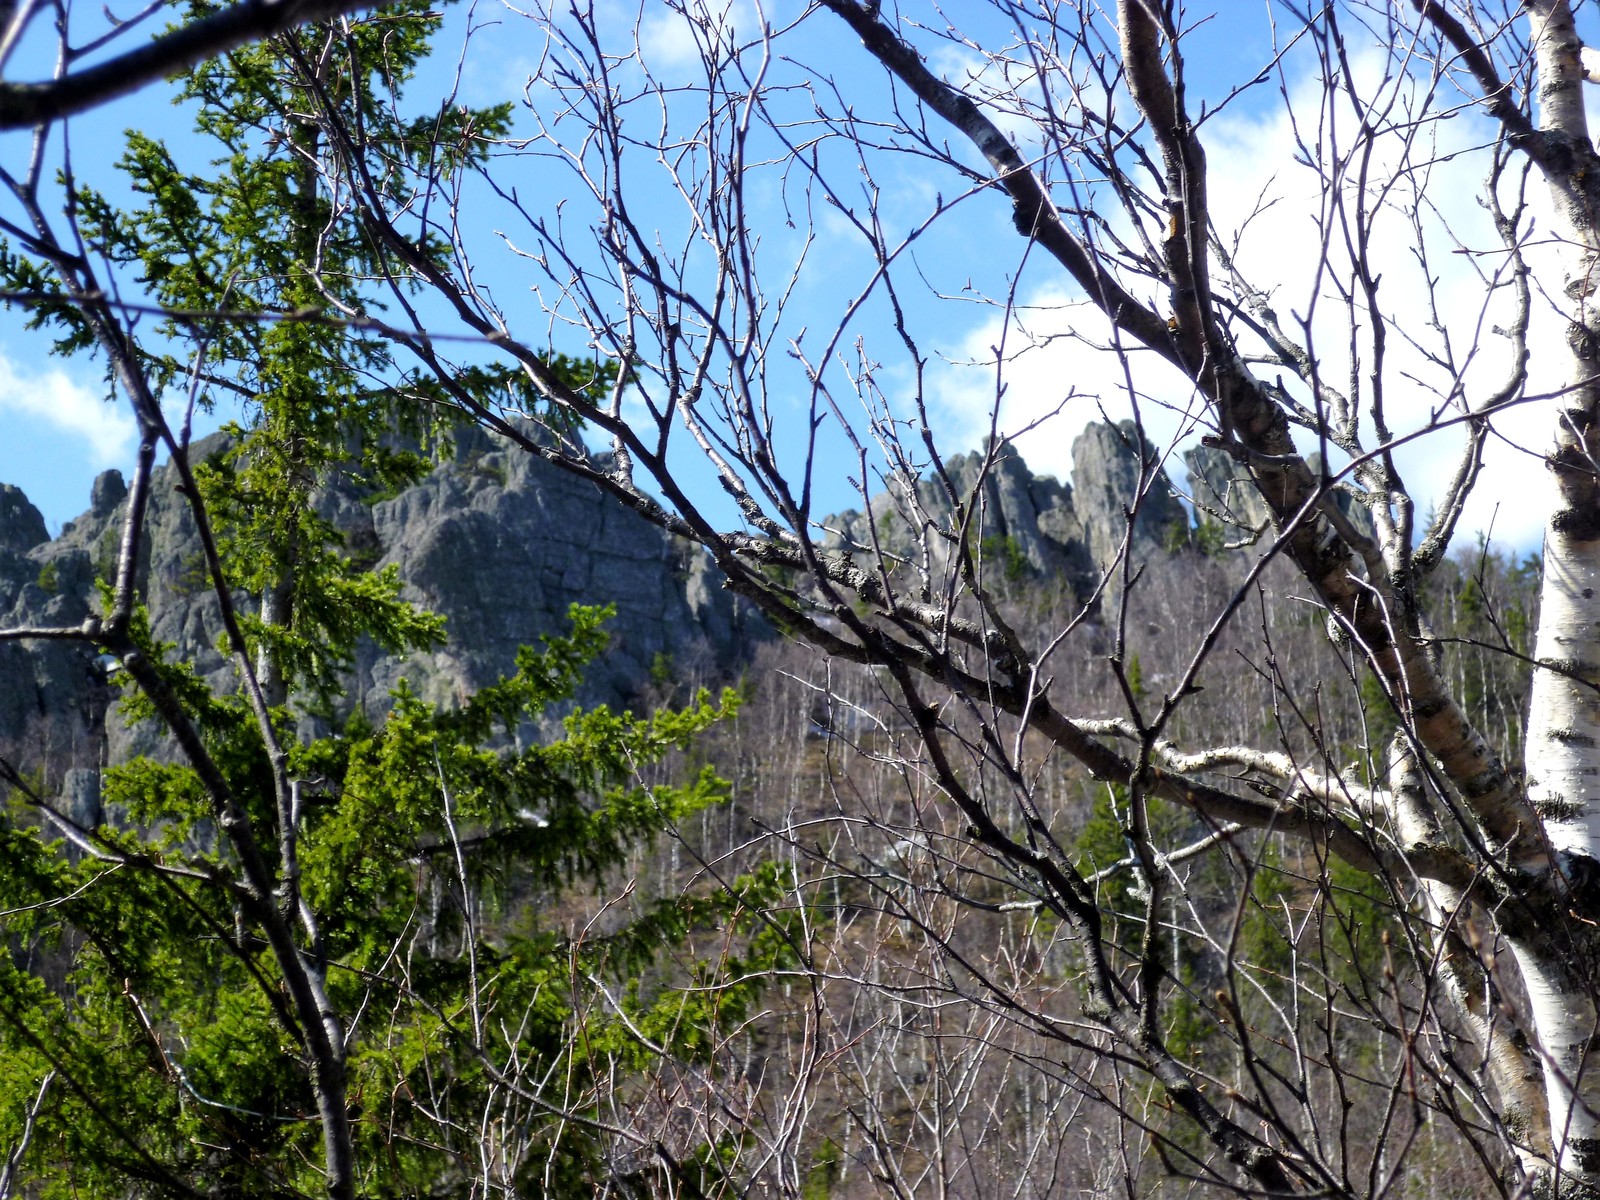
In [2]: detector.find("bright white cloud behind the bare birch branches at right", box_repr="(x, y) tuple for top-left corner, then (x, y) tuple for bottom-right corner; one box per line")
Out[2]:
(931, 51), (1565, 547)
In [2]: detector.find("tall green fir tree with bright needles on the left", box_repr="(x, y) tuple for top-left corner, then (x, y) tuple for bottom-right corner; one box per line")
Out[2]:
(0, 5), (790, 1197)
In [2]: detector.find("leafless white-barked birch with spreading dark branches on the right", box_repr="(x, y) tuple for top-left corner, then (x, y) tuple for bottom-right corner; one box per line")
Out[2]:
(291, 0), (1600, 1194)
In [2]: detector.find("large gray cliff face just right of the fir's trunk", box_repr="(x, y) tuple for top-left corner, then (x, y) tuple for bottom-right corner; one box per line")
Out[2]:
(338, 430), (748, 729)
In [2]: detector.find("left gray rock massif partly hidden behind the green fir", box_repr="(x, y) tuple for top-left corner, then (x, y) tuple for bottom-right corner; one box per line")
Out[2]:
(0, 430), (768, 774)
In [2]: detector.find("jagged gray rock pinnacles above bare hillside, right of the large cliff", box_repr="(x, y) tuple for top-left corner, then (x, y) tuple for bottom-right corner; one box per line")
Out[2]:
(824, 422), (1189, 597)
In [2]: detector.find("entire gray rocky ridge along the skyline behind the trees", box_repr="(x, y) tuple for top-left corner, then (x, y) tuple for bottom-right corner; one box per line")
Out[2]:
(0, 422), (1264, 789)
